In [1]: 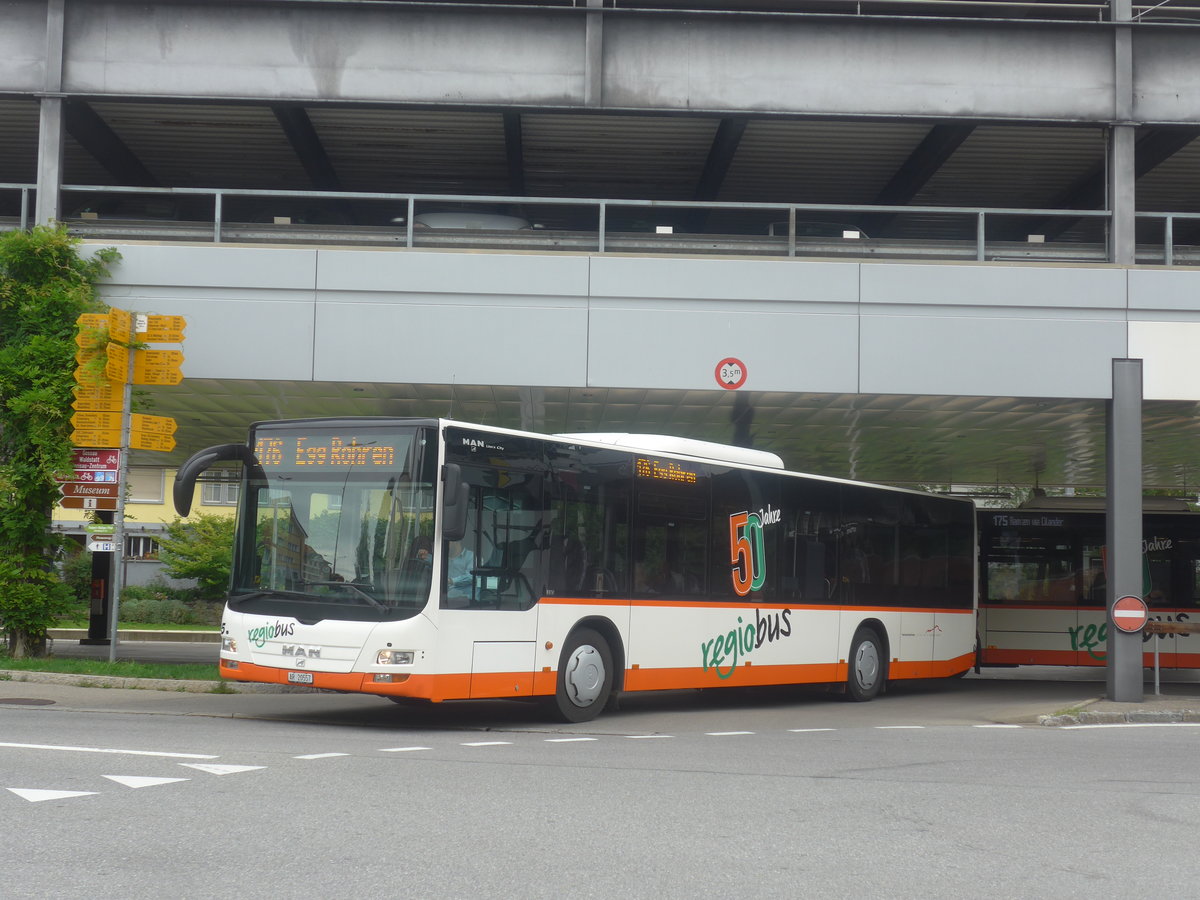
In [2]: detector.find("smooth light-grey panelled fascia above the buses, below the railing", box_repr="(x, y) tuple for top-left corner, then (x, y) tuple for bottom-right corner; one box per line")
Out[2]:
(96, 244), (1200, 400)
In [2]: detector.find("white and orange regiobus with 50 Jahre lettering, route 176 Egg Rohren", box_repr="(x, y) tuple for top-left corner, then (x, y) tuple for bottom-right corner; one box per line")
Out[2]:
(175, 418), (976, 721)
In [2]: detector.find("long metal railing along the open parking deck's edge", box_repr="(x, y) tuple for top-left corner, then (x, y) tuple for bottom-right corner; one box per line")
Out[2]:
(0, 182), (1200, 265)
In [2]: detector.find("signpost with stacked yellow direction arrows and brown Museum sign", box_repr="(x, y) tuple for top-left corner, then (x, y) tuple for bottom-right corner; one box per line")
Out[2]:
(69, 308), (187, 662)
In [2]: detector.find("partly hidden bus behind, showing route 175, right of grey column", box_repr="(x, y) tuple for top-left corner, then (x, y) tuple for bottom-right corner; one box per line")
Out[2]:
(979, 498), (1200, 668)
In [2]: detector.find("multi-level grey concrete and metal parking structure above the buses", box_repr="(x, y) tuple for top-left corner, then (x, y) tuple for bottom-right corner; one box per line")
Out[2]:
(7, 0), (1200, 492)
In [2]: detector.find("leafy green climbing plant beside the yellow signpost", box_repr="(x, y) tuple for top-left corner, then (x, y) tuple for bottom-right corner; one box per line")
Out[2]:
(0, 227), (119, 656)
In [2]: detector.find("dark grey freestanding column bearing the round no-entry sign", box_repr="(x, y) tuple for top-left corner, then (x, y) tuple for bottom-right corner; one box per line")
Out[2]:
(1105, 359), (1142, 703)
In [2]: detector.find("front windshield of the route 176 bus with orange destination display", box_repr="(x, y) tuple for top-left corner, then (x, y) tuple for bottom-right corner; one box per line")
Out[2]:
(229, 421), (437, 622)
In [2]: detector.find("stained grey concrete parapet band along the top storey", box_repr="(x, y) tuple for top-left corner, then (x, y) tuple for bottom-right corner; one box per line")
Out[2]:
(0, 0), (1200, 124)
